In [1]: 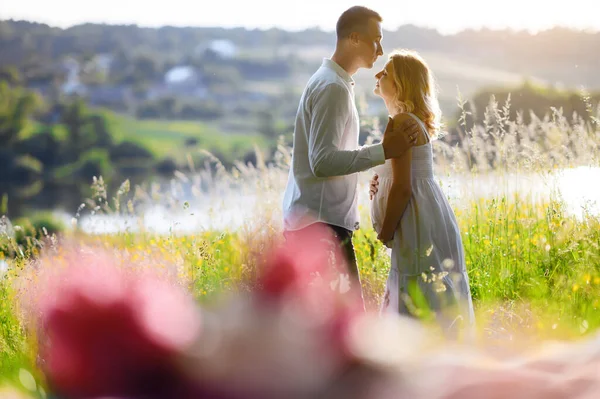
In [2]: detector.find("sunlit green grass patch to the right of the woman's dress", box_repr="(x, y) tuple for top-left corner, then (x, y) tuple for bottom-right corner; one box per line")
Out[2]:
(459, 197), (600, 338)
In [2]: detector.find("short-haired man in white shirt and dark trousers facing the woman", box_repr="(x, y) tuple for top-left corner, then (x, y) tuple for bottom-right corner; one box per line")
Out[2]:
(283, 6), (419, 300)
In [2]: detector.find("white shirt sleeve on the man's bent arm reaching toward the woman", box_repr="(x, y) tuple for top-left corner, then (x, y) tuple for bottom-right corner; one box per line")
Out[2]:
(308, 83), (385, 177)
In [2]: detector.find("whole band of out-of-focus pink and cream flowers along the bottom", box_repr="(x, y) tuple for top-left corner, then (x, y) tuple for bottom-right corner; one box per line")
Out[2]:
(0, 225), (600, 399)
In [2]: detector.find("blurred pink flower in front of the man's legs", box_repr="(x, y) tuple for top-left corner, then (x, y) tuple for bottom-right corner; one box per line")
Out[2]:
(257, 224), (364, 360)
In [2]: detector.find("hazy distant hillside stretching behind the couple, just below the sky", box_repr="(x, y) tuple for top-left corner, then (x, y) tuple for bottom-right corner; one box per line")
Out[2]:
(0, 20), (600, 120)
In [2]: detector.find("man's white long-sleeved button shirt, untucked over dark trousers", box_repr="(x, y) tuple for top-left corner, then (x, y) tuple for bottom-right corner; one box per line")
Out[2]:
(283, 59), (385, 230)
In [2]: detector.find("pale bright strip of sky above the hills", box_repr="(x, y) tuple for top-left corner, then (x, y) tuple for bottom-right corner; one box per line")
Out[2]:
(0, 0), (600, 34)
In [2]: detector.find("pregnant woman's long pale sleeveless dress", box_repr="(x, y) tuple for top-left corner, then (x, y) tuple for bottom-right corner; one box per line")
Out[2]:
(371, 114), (475, 331)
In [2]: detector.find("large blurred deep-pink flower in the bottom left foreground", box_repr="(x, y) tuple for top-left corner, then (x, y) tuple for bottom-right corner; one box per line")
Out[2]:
(38, 251), (200, 397)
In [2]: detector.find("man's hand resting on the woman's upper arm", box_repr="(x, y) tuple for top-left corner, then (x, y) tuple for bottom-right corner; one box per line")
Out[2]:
(383, 115), (421, 159)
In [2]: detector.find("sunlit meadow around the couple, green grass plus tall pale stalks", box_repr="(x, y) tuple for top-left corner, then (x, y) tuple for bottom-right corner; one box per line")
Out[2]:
(0, 100), (600, 397)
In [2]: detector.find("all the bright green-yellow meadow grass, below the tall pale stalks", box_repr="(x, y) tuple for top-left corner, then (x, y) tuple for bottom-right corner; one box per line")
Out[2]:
(0, 191), (600, 396)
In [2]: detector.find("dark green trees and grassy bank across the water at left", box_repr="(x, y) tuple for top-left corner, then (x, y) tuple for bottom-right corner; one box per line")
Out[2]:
(0, 82), (276, 217)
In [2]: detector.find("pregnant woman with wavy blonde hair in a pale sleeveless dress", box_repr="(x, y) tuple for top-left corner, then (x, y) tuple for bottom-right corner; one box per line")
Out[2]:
(371, 50), (474, 331)
